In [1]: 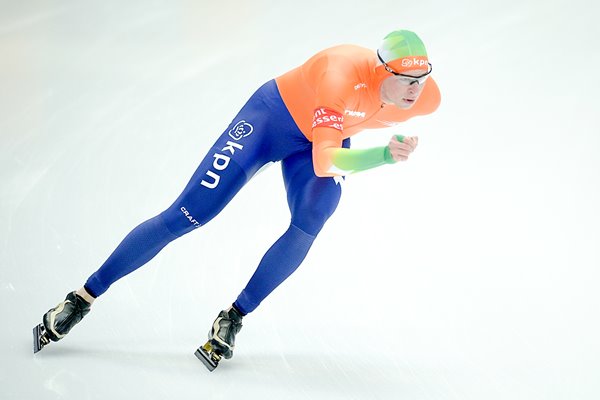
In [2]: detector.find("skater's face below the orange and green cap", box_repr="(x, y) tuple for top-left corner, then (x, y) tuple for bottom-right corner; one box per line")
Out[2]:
(380, 69), (429, 110)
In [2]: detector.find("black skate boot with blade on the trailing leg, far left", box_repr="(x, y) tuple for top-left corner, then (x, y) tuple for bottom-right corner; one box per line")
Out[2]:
(33, 292), (91, 353)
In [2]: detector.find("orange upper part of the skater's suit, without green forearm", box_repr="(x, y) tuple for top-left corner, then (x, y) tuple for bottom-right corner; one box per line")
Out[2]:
(275, 45), (440, 176)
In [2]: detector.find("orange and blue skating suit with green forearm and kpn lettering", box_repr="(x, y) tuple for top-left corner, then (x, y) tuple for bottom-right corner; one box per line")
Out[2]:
(85, 45), (440, 313)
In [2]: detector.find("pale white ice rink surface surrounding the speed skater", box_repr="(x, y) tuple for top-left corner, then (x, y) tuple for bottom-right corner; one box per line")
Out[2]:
(0, 0), (600, 400)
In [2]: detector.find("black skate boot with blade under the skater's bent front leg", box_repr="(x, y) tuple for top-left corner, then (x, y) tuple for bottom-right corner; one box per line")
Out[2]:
(195, 306), (242, 371)
